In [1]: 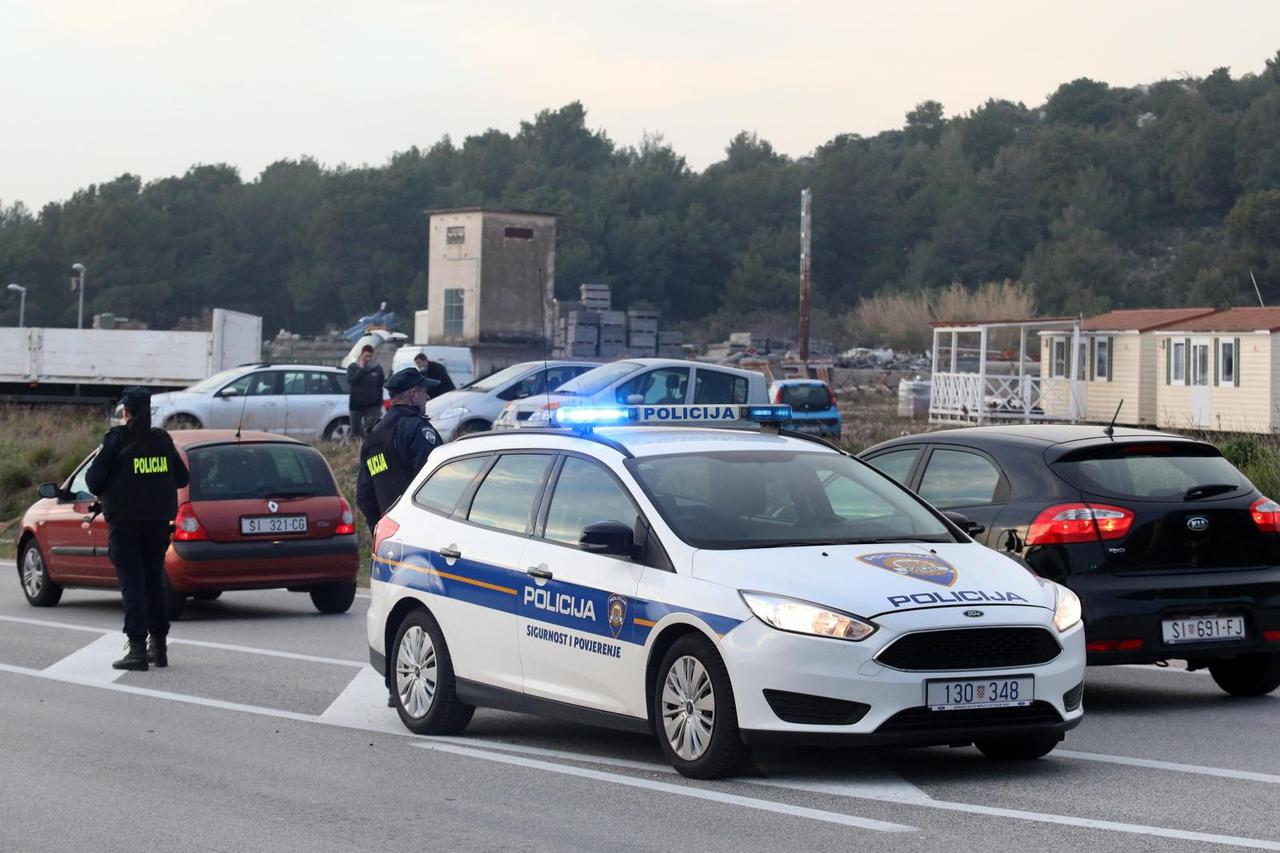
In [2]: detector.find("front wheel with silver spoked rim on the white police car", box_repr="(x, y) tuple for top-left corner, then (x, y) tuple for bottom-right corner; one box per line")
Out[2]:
(653, 634), (748, 779)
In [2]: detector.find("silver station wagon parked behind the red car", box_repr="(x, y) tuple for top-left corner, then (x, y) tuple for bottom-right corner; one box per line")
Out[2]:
(115, 364), (351, 441)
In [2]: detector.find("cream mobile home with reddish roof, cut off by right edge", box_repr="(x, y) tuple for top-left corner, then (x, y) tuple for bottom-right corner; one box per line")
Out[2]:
(1156, 307), (1280, 433)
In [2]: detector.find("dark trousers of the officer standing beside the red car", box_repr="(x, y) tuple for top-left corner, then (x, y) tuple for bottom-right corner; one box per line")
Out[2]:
(106, 521), (169, 640)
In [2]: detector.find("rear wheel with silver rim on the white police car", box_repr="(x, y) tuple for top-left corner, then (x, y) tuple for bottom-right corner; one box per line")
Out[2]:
(392, 610), (475, 735)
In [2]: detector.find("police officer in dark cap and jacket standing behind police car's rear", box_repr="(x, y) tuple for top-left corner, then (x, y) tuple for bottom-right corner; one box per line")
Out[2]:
(356, 368), (444, 530)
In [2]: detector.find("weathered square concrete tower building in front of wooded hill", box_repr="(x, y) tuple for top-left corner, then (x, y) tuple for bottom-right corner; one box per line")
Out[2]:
(426, 207), (556, 366)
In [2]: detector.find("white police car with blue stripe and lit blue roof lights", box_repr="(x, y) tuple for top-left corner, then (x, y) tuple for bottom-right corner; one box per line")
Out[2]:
(369, 406), (1084, 777)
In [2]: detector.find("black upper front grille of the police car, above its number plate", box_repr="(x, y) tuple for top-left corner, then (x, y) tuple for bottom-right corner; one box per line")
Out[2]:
(876, 628), (1062, 671)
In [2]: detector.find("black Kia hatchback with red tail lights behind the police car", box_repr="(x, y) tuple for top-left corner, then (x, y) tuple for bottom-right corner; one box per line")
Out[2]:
(861, 424), (1280, 695)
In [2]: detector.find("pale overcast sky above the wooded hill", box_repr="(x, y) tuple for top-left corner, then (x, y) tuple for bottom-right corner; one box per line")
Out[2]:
(0, 0), (1280, 210)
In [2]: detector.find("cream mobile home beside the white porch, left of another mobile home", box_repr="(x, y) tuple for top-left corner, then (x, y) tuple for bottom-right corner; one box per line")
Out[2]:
(1041, 307), (1213, 427)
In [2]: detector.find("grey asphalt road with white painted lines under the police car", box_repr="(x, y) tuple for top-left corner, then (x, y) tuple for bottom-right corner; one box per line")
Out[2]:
(0, 564), (1280, 853)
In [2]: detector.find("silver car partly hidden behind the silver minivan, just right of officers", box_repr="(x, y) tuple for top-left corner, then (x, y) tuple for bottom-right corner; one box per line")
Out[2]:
(426, 361), (599, 441)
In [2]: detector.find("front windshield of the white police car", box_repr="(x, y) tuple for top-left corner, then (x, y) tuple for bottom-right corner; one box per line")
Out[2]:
(627, 451), (956, 551)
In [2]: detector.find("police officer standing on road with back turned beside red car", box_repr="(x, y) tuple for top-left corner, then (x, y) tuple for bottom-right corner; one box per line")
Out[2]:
(84, 388), (191, 671)
